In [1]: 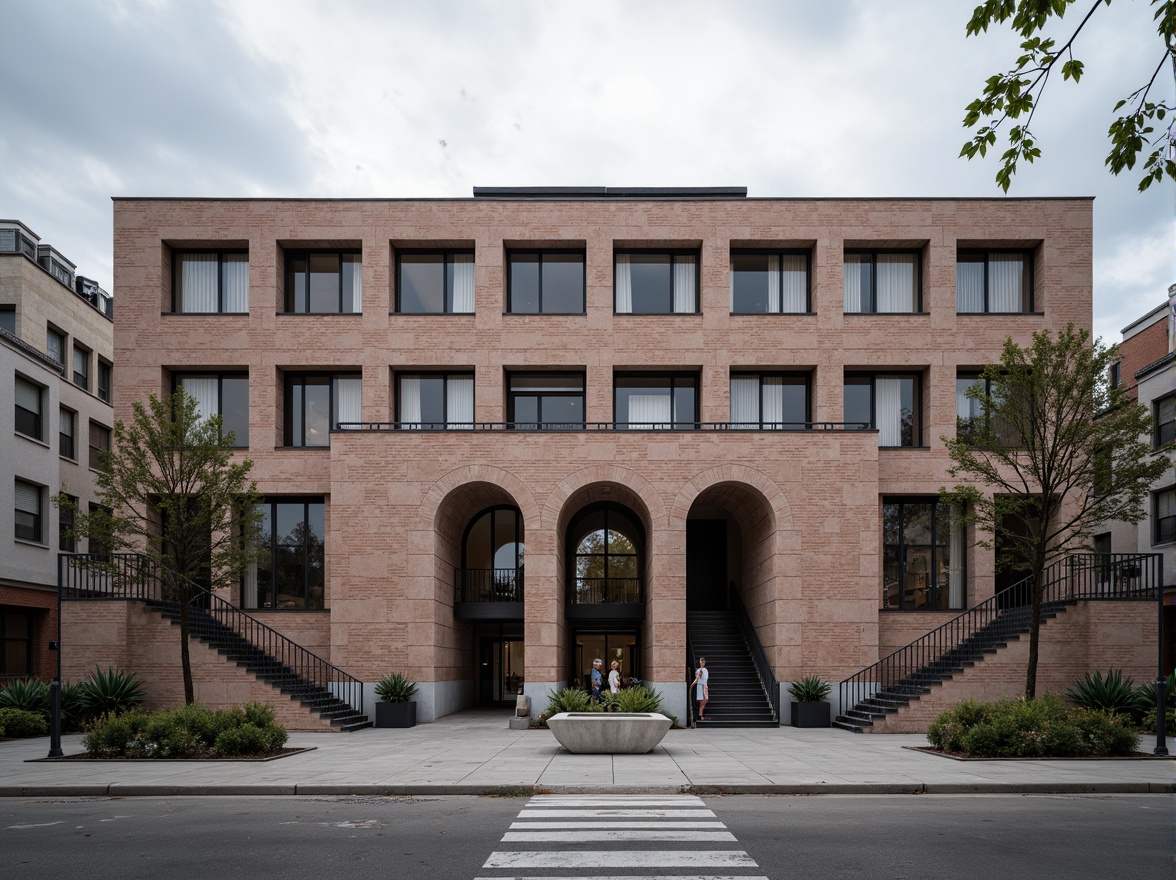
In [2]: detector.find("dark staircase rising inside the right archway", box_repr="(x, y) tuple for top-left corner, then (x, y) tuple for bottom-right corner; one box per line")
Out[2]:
(686, 611), (780, 729)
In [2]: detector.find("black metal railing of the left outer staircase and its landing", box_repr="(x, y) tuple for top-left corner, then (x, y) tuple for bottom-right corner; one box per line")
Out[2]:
(58, 553), (363, 713)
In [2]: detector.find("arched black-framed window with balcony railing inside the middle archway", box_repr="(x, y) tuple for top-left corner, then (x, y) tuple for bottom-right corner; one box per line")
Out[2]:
(568, 502), (644, 605)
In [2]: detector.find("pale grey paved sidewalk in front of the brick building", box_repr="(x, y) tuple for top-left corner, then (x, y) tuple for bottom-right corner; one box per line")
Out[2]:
(0, 712), (1176, 796)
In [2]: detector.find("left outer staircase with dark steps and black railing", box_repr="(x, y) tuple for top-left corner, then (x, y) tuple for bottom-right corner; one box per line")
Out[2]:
(58, 553), (372, 731)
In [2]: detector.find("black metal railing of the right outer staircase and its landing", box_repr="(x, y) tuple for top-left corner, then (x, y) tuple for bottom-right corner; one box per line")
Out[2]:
(840, 553), (1163, 713)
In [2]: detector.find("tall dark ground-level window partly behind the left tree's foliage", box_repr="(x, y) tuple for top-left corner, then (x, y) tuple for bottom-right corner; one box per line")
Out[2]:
(241, 498), (326, 611)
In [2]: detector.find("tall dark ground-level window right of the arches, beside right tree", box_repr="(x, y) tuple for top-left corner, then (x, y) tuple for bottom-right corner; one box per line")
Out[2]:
(882, 498), (964, 611)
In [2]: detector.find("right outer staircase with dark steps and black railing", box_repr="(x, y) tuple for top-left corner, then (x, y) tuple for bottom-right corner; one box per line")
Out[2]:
(833, 553), (1162, 733)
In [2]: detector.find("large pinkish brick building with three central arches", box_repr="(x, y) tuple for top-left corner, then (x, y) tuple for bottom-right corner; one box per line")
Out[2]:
(75, 187), (1154, 720)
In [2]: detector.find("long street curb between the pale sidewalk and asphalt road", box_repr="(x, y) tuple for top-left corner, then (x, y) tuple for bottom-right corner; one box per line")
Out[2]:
(0, 782), (1176, 798)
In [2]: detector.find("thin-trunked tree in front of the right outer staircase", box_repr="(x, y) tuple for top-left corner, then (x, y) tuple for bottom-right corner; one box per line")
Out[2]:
(941, 324), (1168, 700)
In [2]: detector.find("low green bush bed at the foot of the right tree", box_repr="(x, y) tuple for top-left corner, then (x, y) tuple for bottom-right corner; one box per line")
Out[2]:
(927, 694), (1138, 758)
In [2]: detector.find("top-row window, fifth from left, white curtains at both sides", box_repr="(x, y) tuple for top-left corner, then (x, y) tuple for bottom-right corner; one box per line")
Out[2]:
(614, 251), (699, 315)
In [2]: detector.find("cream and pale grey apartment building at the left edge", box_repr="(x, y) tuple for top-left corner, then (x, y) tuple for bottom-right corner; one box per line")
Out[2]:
(0, 220), (114, 681)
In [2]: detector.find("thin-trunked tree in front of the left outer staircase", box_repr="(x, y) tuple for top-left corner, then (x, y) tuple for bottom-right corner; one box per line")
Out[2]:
(54, 388), (261, 704)
